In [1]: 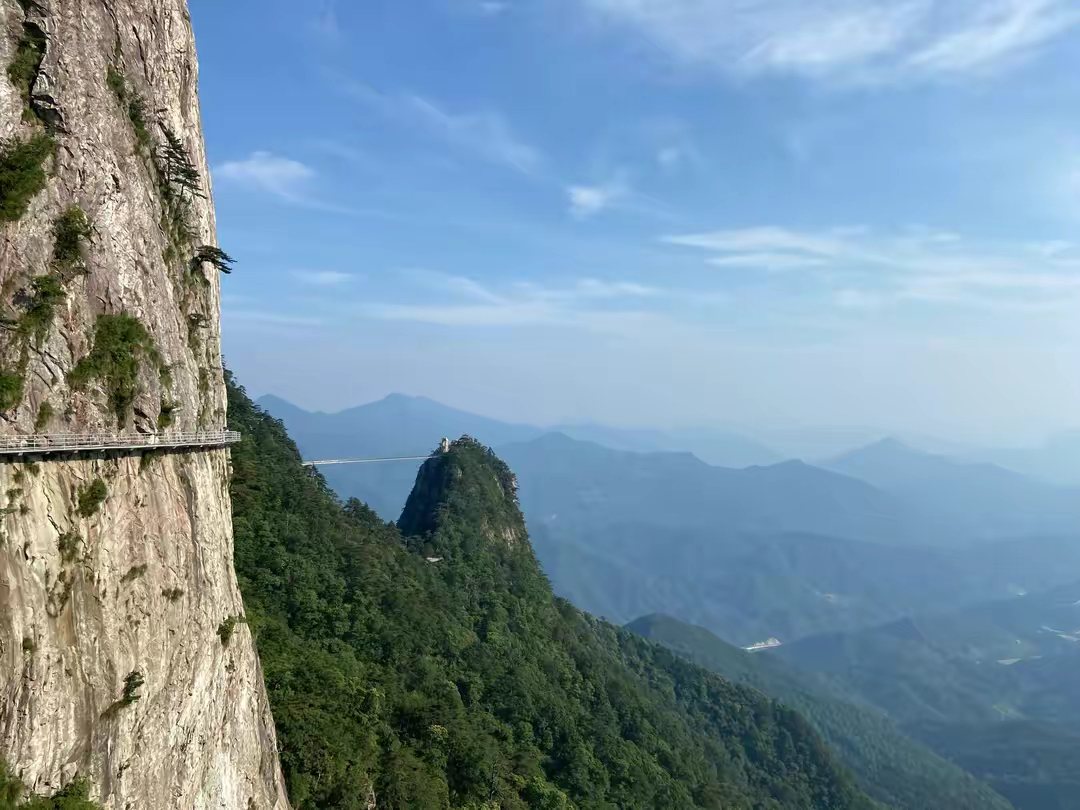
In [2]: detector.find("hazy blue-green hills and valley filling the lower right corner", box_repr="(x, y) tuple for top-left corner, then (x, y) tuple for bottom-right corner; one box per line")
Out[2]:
(773, 583), (1080, 810)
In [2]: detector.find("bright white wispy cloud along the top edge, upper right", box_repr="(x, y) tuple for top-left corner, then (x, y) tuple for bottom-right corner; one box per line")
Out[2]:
(580, 0), (1080, 82)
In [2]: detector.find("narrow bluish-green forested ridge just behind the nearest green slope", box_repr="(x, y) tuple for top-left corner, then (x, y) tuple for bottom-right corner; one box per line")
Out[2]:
(627, 616), (1010, 810)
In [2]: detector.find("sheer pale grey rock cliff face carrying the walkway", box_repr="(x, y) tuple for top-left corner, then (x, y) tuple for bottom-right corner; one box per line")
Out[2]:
(0, 0), (287, 810)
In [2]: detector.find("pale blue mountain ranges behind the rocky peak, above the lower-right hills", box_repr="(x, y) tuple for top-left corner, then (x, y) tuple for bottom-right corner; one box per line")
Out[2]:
(260, 396), (1080, 645)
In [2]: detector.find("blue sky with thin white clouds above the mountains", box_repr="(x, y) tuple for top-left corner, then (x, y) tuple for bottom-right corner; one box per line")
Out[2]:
(190, 0), (1080, 442)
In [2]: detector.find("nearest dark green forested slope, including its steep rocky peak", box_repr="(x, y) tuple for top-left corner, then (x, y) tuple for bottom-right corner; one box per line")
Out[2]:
(229, 380), (872, 810)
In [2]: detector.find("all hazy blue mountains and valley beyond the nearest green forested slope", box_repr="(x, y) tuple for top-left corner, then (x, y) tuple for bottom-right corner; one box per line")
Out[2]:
(261, 396), (1080, 810)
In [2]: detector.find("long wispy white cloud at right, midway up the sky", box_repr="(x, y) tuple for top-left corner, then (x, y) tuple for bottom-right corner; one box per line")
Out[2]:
(664, 227), (1080, 310)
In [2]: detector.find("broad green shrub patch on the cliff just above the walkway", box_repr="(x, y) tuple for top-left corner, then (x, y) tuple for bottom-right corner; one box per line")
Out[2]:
(68, 314), (166, 427)
